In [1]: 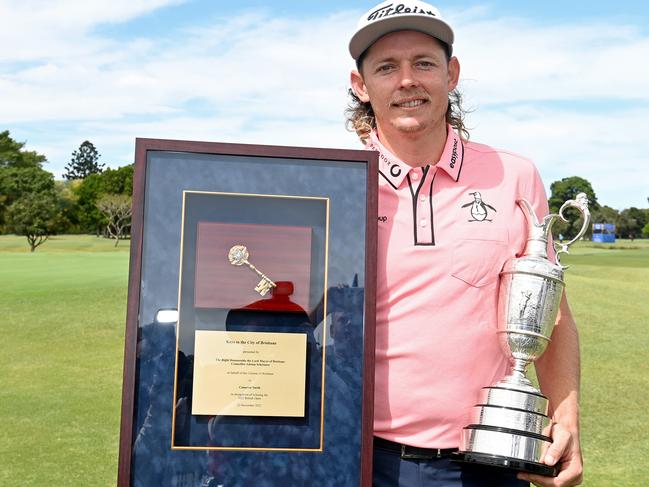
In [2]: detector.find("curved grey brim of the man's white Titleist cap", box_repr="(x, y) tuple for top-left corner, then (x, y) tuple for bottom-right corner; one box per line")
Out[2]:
(349, 15), (454, 59)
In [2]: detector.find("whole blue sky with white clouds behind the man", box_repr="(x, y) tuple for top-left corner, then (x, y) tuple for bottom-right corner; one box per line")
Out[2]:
(0, 0), (649, 209)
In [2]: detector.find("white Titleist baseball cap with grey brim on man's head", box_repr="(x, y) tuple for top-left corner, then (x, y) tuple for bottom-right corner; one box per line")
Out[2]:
(349, 0), (454, 60)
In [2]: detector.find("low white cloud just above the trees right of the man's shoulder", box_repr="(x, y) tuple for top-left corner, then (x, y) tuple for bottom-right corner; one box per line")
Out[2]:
(469, 106), (649, 209)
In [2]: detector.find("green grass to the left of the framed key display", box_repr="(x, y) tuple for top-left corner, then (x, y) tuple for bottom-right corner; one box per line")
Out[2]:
(0, 236), (128, 486)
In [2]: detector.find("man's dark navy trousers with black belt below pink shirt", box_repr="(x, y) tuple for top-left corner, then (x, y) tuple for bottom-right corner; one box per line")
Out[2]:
(373, 446), (529, 487)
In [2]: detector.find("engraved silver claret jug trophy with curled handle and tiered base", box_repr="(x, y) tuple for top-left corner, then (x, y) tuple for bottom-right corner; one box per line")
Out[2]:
(456, 193), (590, 476)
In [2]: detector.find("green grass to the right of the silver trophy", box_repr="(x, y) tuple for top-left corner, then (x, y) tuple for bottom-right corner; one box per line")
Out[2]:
(562, 240), (649, 487)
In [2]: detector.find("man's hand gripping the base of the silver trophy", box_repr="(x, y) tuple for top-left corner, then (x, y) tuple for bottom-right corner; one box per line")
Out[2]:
(518, 424), (583, 487)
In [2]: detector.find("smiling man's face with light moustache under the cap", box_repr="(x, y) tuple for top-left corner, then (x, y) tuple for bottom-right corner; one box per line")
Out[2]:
(351, 31), (460, 135)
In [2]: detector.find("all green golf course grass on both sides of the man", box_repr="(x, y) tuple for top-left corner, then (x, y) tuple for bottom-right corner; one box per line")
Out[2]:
(0, 236), (649, 487)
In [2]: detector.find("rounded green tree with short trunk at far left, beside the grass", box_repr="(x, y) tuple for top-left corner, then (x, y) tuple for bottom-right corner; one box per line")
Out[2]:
(7, 191), (58, 252)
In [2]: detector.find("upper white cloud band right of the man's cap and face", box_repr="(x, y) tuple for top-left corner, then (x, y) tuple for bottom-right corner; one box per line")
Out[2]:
(456, 19), (649, 103)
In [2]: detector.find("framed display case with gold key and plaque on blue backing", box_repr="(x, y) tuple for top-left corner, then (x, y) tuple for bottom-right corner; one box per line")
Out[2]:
(118, 139), (378, 487)
